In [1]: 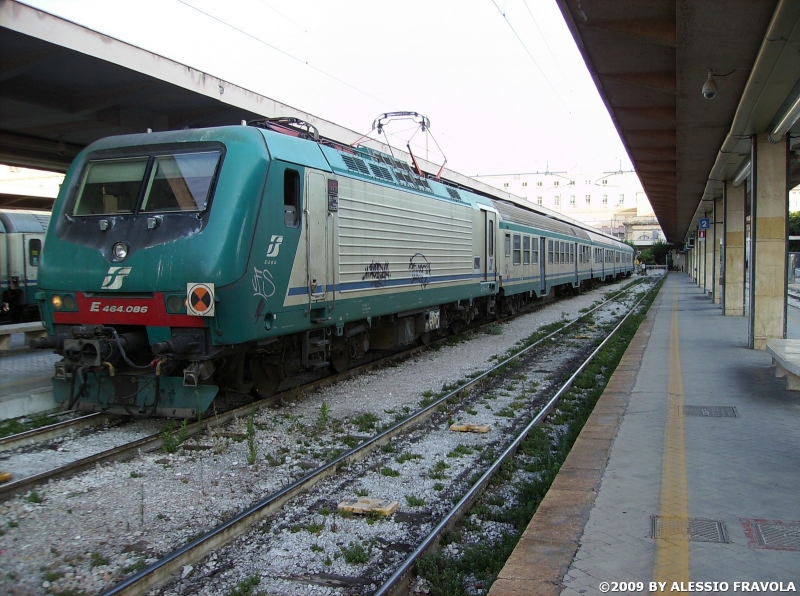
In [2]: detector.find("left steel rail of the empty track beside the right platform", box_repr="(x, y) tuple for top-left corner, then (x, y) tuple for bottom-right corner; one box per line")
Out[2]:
(101, 280), (641, 596)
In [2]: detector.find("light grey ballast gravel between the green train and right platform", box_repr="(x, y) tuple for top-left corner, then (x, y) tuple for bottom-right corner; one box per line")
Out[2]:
(0, 283), (640, 596)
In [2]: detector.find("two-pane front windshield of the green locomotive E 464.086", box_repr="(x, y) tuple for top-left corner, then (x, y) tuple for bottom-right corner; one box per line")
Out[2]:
(72, 151), (220, 215)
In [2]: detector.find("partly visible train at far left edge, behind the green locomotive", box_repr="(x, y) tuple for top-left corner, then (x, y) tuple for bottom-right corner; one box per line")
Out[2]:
(0, 209), (50, 323)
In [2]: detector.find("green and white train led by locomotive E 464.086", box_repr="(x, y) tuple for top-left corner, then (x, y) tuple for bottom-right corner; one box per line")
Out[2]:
(31, 120), (633, 418)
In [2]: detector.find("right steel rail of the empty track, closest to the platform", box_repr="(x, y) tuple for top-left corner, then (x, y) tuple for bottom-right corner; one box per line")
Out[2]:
(373, 284), (658, 596)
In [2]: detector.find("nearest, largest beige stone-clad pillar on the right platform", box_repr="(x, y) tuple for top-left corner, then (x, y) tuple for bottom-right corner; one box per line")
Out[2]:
(748, 133), (789, 350)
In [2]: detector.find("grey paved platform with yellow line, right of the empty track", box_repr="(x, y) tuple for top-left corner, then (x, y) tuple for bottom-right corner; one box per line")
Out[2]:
(489, 273), (800, 596)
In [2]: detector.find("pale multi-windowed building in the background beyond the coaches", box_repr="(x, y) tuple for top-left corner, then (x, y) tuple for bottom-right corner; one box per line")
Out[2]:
(475, 168), (665, 248)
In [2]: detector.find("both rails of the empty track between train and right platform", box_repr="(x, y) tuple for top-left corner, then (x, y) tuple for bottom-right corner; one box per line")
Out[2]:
(97, 284), (652, 596)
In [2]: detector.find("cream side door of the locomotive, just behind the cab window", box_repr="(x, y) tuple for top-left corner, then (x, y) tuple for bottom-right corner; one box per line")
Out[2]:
(306, 172), (333, 302)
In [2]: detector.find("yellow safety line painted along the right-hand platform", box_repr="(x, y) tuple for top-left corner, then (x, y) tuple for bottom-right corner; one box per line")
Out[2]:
(654, 284), (689, 594)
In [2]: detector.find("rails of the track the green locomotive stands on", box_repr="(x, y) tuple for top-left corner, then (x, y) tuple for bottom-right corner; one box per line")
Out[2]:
(0, 278), (612, 501)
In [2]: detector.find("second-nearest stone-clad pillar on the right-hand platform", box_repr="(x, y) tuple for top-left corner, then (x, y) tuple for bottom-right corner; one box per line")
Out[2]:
(722, 181), (747, 317)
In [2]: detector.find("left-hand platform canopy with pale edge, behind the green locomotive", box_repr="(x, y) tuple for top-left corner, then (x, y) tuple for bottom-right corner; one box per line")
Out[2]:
(0, 0), (586, 227)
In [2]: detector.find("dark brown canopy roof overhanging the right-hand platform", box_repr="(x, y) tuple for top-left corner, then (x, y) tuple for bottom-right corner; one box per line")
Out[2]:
(557, 0), (800, 242)
